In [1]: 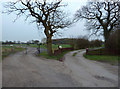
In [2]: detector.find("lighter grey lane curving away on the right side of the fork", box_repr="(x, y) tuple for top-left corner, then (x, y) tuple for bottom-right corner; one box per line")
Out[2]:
(64, 50), (118, 87)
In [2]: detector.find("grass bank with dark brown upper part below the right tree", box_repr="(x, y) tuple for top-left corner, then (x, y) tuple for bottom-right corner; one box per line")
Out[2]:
(84, 48), (120, 65)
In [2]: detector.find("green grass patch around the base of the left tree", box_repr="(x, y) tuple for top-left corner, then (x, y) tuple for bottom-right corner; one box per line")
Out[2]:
(38, 51), (70, 60)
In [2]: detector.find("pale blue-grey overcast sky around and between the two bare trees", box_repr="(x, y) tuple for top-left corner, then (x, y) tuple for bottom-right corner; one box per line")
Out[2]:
(0, 0), (102, 41)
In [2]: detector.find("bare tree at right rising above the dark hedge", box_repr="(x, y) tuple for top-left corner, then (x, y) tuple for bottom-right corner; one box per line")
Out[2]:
(75, 1), (120, 47)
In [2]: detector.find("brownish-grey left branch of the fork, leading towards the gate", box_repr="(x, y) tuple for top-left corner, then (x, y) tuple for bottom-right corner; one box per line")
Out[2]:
(2, 48), (79, 87)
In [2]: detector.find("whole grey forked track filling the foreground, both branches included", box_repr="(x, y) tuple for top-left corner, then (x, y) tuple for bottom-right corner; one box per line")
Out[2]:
(2, 48), (118, 87)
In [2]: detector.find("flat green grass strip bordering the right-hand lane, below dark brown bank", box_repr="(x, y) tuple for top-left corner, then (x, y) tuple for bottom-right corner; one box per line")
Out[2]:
(84, 54), (120, 65)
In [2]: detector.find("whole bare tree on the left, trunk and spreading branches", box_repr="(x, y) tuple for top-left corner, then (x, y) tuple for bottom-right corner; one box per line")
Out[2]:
(5, 0), (71, 55)
